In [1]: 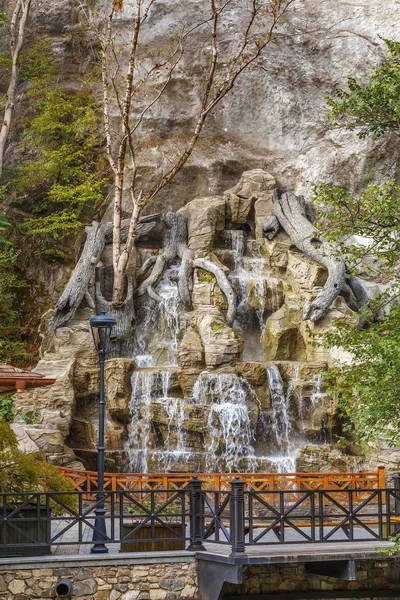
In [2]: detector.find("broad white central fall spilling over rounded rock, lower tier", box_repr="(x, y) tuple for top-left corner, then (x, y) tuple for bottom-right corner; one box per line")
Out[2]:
(192, 372), (254, 472)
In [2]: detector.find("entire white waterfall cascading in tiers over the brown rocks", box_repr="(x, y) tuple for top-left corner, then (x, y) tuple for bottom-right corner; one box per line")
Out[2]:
(126, 218), (330, 472)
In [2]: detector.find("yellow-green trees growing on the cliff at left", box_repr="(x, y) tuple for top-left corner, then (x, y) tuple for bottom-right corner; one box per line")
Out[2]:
(0, 32), (106, 365)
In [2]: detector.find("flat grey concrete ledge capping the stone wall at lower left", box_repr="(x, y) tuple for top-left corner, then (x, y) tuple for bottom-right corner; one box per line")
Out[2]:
(0, 550), (196, 571)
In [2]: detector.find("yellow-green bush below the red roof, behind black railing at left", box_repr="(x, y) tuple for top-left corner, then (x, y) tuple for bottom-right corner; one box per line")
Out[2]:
(0, 419), (77, 516)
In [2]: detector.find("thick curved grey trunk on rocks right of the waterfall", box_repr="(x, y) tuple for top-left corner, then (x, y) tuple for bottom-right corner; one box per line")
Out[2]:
(269, 191), (346, 323)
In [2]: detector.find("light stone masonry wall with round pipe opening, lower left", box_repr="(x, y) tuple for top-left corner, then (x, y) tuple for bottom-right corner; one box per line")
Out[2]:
(0, 561), (197, 600)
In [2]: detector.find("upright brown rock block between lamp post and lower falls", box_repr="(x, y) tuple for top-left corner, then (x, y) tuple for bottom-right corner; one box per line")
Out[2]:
(105, 358), (135, 423)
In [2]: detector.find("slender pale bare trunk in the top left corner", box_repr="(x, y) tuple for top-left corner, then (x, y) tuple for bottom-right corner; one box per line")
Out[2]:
(0, 0), (32, 178)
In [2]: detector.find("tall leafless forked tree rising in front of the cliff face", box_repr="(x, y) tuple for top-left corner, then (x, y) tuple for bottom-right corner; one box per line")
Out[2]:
(89, 0), (295, 302)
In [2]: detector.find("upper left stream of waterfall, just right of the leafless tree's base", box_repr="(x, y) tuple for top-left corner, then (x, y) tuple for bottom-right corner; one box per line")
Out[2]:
(134, 263), (180, 368)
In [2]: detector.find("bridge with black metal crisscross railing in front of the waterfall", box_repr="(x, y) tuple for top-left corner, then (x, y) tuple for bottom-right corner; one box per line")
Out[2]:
(0, 468), (400, 600)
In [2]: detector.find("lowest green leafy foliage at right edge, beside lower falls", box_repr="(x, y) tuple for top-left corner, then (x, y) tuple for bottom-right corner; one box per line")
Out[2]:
(324, 306), (400, 446)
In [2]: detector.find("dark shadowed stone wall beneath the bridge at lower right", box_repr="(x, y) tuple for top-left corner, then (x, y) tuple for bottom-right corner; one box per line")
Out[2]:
(224, 558), (400, 598)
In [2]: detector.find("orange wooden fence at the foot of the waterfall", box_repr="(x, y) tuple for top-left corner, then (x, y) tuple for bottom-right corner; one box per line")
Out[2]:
(59, 467), (385, 501)
